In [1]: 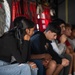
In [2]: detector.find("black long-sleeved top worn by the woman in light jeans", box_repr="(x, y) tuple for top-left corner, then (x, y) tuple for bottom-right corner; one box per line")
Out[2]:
(0, 33), (30, 63)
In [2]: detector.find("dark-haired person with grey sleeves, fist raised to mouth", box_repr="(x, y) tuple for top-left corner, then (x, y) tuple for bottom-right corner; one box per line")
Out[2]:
(47, 18), (72, 75)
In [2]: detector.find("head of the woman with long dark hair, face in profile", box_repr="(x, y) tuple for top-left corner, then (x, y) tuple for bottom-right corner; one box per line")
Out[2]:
(14, 17), (35, 38)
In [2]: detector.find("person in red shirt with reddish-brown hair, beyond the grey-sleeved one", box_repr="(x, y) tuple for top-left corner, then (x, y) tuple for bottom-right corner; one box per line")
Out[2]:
(64, 24), (75, 74)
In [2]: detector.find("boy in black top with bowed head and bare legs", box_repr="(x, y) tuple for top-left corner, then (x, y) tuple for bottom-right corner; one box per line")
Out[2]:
(31, 22), (69, 75)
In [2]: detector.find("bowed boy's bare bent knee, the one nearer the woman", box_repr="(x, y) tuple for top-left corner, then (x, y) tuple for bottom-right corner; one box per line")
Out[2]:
(46, 60), (57, 75)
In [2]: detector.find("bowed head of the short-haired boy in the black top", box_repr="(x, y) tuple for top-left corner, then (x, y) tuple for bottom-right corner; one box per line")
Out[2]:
(44, 22), (59, 40)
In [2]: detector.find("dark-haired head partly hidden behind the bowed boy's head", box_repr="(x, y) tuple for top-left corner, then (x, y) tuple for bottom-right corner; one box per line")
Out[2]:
(53, 18), (66, 34)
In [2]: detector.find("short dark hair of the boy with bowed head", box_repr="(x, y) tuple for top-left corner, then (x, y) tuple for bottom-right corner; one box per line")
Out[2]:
(45, 22), (59, 34)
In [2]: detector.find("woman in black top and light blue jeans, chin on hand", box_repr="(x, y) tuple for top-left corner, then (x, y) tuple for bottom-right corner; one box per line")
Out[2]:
(0, 17), (37, 75)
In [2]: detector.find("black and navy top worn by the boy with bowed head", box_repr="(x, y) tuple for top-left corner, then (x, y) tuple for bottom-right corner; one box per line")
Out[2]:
(31, 31), (62, 63)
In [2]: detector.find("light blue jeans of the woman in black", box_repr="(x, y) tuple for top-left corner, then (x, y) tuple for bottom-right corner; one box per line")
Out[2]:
(0, 61), (37, 75)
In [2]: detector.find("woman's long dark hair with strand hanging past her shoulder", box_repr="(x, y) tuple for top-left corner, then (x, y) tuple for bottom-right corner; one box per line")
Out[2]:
(13, 16), (35, 47)
